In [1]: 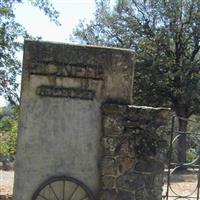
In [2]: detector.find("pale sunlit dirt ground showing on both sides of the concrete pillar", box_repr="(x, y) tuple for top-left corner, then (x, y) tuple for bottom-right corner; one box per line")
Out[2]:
(0, 170), (198, 200)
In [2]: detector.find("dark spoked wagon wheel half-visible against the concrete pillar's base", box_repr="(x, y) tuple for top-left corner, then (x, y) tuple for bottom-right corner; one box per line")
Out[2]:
(32, 177), (94, 200)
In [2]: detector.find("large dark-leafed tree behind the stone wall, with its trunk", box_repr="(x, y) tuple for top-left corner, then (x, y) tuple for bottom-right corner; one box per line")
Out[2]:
(71, 0), (200, 163)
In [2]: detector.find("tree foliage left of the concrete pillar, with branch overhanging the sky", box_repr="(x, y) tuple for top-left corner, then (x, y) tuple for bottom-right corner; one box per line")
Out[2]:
(0, 0), (59, 104)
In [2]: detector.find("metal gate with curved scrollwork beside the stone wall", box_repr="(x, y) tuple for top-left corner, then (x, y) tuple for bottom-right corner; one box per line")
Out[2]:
(163, 117), (200, 200)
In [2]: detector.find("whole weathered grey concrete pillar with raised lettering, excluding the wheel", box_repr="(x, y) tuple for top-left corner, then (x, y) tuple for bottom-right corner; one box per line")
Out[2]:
(14, 41), (133, 200)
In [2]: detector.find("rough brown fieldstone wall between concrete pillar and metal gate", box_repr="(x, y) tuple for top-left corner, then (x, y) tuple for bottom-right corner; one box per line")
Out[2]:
(100, 104), (169, 200)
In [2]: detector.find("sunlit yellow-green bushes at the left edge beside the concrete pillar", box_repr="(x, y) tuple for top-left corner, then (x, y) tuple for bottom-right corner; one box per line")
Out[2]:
(0, 104), (18, 157)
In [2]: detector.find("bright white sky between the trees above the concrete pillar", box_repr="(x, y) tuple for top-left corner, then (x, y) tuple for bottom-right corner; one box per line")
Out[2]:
(0, 0), (95, 106)
